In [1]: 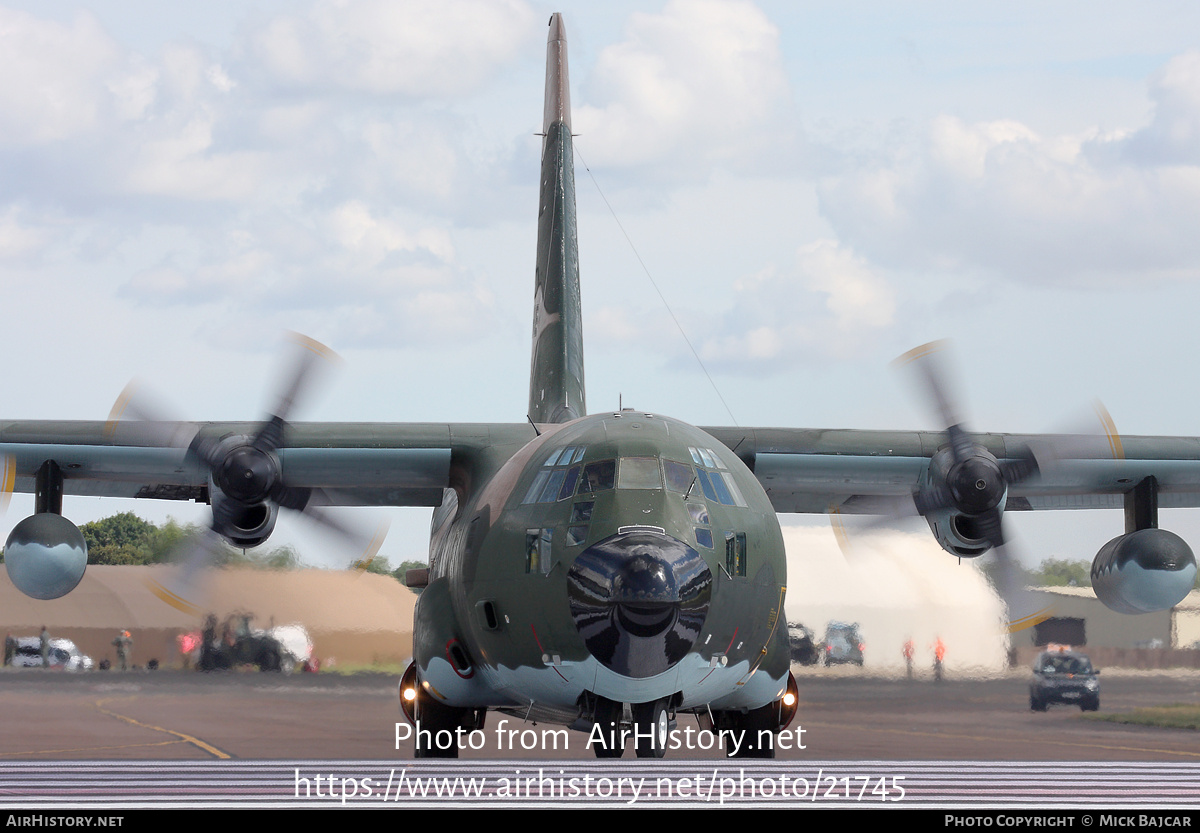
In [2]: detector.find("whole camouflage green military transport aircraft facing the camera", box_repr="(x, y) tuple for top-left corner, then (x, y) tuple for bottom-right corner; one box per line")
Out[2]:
(0, 14), (1200, 756)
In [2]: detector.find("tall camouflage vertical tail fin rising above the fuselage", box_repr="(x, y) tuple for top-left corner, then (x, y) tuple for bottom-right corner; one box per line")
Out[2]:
(529, 13), (587, 423)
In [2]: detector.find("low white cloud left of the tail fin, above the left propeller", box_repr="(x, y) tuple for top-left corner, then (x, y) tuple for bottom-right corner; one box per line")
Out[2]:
(120, 200), (494, 347)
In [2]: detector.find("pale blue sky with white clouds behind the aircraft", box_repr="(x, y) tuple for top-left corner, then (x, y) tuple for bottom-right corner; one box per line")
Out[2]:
(0, 0), (1200, 571)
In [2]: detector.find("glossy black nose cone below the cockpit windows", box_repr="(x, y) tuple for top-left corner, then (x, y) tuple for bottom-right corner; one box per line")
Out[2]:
(566, 529), (713, 678)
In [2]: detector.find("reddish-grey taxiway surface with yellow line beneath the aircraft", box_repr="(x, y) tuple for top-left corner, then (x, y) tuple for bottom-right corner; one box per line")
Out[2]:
(0, 670), (1200, 762)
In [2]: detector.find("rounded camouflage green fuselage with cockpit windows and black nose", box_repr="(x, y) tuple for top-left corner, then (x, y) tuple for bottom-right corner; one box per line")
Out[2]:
(415, 410), (787, 723)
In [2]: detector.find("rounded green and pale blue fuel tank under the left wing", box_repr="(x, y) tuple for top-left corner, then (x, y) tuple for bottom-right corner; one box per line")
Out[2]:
(4, 513), (88, 600)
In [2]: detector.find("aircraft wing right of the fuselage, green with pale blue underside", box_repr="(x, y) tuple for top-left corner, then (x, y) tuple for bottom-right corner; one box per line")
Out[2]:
(703, 427), (1200, 514)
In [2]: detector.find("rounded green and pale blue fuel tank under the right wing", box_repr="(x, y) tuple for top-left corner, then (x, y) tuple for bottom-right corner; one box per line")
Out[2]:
(1092, 528), (1196, 613)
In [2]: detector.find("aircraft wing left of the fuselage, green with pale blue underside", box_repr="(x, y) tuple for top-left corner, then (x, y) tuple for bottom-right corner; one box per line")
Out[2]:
(0, 421), (534, 507)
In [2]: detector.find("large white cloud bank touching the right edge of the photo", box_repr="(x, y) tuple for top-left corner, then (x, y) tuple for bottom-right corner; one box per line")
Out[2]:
(820, 54), (1200, 284)
